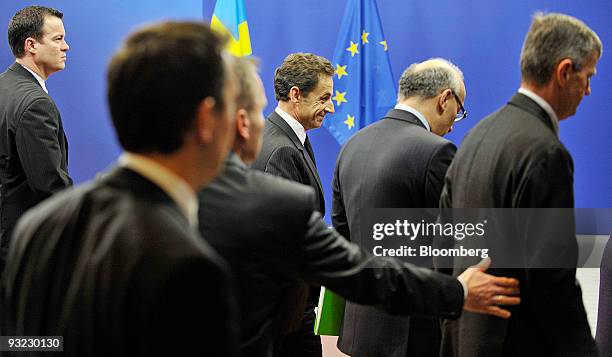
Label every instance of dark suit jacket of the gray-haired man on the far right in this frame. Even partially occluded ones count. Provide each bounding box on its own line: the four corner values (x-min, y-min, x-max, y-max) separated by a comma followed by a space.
440, 94, 597, 357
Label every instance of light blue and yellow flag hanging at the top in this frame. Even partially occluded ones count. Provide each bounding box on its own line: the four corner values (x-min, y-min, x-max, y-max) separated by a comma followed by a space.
210, 0, 252, 57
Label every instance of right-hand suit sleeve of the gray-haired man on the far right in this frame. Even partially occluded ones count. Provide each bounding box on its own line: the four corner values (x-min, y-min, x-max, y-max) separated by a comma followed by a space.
516, 147, 596, 356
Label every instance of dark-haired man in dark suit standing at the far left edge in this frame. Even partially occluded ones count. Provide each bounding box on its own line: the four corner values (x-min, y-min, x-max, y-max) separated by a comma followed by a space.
0, 6, 72, 276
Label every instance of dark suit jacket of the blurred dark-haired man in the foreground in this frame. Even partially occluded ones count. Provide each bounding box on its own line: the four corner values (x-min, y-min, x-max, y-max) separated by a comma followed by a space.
0, 168, 237, 356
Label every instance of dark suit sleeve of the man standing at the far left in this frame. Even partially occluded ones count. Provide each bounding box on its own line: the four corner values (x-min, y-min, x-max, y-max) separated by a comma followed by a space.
15, 99, 72, 197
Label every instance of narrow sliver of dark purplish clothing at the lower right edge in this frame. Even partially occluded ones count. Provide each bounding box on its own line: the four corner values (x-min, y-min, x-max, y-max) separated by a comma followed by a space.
597, 235, 612, 357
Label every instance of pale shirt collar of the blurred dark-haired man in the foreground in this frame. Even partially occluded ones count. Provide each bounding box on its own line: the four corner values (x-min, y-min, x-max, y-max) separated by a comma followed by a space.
118, 152, 198, 227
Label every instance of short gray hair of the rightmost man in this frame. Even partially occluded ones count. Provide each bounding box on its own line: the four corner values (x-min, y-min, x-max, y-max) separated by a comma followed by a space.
521, 12, 603, 85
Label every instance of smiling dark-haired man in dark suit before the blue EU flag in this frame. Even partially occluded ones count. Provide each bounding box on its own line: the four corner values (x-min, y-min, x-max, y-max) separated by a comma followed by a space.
253, 53, 334, 356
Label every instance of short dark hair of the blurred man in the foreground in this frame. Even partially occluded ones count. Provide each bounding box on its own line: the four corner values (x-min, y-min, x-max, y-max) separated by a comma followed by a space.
107, 22, 226, 154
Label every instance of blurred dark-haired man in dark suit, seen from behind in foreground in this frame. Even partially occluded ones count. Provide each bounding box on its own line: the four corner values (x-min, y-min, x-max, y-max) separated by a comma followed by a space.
0, 22, 237, 356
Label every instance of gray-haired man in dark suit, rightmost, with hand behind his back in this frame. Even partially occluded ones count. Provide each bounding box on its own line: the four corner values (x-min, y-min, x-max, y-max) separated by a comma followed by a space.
441, 14, 602, 357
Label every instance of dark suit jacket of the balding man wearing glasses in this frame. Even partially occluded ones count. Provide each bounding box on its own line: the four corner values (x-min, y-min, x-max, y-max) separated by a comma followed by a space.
332, 109, 456, 357
